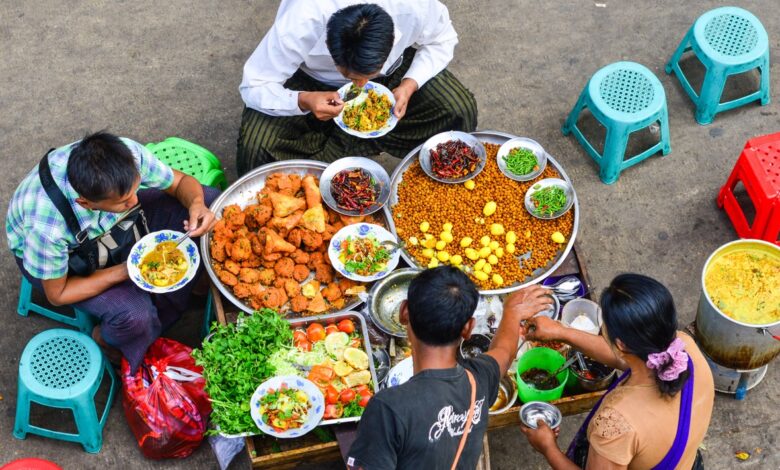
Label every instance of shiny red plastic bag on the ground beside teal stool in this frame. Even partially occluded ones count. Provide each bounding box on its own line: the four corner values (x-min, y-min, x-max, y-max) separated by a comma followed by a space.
122, 338, 211, 459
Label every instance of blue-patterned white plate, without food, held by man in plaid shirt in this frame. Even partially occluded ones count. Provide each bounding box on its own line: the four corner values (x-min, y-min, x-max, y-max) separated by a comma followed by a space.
127, 230, 200, 294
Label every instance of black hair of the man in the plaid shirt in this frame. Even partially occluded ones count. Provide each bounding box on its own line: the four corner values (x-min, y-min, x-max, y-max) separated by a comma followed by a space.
67, 131, 139, 201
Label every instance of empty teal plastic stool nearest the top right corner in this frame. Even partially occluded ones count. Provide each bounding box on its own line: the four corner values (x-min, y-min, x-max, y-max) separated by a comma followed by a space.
666, 7, 770, 125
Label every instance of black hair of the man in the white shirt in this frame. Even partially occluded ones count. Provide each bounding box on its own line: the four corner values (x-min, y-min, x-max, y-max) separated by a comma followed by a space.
325, 3, 395, 75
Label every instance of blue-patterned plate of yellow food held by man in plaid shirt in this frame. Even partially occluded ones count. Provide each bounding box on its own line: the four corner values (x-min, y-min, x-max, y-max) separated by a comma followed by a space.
127, 230, 200, 294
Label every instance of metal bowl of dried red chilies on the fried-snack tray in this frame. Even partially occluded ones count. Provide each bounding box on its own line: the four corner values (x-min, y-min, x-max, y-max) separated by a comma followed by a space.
320, 157, 390, 216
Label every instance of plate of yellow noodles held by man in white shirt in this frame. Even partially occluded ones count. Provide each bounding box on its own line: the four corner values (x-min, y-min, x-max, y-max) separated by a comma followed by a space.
334, 82, 398, 139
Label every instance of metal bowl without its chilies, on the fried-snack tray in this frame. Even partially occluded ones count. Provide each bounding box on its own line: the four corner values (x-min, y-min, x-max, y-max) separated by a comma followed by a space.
320, 157, 390, 217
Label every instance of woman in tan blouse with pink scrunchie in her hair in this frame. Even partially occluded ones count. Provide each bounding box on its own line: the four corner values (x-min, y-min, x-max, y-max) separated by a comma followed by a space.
522, 274, 715, 470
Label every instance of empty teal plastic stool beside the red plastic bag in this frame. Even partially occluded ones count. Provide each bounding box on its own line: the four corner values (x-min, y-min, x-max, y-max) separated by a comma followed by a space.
14, 328, 117, 453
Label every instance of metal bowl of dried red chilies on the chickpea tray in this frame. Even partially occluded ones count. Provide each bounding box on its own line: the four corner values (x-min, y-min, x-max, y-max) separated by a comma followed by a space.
419, 131, 487, 184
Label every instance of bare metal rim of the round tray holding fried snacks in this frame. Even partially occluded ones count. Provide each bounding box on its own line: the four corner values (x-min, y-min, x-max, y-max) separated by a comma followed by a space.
200, 160, 388, 313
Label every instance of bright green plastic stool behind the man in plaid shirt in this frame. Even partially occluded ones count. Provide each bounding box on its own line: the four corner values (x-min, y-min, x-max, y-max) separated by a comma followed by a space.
146, 137, 227, 190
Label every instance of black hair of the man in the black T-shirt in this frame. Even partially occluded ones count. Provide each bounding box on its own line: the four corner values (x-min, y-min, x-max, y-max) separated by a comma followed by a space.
407, 266, 479, 346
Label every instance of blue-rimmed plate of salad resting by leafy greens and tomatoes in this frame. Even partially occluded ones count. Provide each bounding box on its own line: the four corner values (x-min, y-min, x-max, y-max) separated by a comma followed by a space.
249, 376, 325, 438
